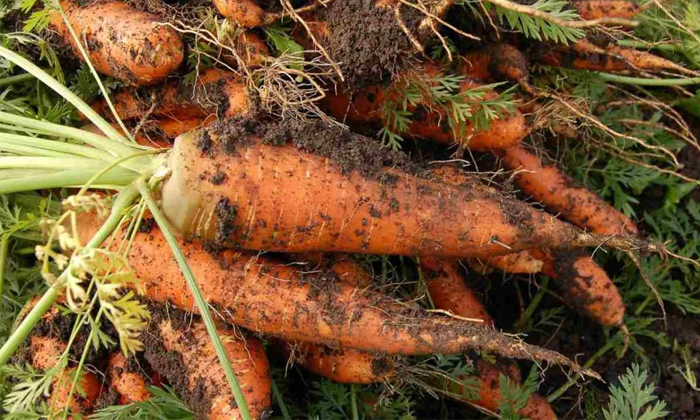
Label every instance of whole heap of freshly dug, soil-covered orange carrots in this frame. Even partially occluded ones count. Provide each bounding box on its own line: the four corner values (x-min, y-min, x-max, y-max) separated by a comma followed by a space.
0, 0, 693, 420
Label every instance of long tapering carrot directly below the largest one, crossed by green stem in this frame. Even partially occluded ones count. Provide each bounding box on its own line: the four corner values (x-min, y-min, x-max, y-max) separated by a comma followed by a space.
80, 214, 578, 370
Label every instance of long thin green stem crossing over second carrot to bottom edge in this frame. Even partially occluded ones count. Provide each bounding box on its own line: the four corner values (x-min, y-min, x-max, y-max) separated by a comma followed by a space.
136, 178, 251, 420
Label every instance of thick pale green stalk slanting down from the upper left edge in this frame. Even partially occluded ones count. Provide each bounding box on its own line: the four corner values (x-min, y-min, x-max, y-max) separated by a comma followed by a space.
0, 46, 125, 143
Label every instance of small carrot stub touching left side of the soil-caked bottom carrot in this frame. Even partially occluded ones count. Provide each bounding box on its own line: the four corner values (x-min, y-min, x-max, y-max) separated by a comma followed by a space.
107, 351, 151, 404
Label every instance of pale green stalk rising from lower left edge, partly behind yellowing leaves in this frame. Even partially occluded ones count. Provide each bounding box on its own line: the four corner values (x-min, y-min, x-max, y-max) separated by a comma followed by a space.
0, 186, 139, 366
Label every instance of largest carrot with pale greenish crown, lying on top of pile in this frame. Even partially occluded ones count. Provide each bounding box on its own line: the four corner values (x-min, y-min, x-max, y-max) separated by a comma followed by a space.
161, 130, 585, 257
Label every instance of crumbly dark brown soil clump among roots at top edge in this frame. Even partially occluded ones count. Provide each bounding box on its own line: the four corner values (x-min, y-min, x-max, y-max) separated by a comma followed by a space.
324, 0, 425, 90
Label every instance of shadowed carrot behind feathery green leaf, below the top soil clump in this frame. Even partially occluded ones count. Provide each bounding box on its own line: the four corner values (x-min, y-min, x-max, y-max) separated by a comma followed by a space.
324, 63, 528, 151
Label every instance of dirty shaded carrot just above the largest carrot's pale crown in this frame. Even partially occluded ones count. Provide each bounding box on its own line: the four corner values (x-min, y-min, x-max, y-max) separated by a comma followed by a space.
93, 69, 250, 120
